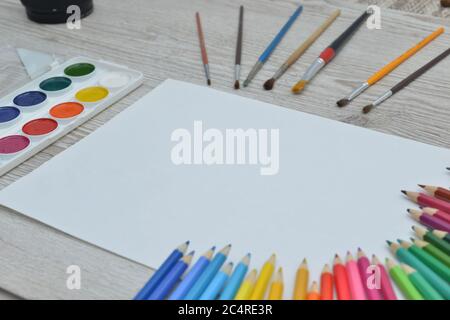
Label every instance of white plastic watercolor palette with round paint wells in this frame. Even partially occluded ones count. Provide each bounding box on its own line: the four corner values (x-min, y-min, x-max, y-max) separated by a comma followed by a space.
0, 57, 143, 175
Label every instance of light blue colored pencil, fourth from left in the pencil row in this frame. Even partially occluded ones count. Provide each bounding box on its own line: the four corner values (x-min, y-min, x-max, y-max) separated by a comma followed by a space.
184, 245, 231, 300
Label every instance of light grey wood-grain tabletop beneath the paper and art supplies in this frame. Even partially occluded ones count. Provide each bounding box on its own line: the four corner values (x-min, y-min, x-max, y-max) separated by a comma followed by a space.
0, 0, 450, 299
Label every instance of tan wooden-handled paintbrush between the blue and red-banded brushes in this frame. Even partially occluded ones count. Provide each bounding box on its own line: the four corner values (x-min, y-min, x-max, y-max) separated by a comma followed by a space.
264, 9, 341, 90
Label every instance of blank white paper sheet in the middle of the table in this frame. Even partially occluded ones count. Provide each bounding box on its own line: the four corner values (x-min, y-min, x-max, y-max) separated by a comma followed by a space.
0, 80, 450, 297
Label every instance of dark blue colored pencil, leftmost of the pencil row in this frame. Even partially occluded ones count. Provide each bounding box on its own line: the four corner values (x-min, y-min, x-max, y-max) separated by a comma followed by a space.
134, 241, 189, 300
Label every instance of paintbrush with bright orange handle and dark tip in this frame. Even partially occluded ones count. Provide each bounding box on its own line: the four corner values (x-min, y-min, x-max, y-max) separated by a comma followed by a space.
337, 28, 444, 108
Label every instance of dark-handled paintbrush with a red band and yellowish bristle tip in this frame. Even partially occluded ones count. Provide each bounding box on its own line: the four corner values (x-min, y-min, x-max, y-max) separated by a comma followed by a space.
292, 10, 372, 93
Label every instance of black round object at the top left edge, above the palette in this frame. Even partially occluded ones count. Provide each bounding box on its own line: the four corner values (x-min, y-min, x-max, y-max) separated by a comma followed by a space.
21, 0, 94, 24
